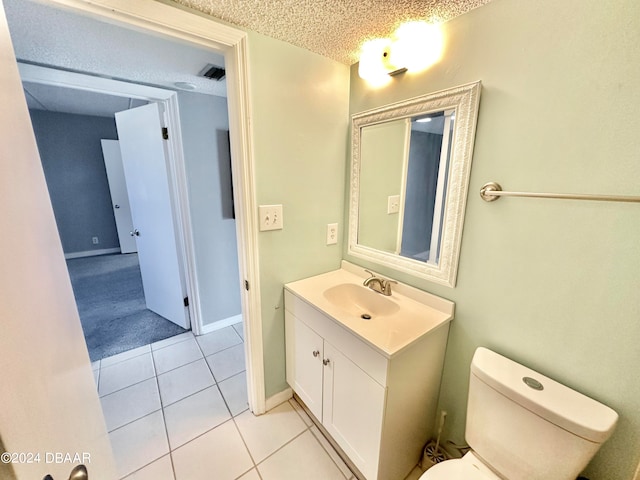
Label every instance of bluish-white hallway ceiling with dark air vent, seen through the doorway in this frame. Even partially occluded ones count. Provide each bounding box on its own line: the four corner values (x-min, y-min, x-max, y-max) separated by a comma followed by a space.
2, 0, 226, 96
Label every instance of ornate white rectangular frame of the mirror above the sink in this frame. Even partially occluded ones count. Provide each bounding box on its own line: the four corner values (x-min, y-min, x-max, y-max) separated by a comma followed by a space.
347, 81, 481, 287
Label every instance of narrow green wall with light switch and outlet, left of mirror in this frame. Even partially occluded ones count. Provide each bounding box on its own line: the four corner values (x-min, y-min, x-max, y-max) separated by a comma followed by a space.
248, 32, 349, 398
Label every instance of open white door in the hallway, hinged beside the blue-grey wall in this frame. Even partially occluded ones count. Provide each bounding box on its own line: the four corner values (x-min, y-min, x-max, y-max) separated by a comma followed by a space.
116, 103, 189, 328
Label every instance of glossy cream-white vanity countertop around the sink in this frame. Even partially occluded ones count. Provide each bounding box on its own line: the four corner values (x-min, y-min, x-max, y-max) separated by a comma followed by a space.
285, 261, 455, 358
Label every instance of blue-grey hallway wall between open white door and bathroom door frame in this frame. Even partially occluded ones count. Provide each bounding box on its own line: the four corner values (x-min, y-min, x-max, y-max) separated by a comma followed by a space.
178, 92, 242, 326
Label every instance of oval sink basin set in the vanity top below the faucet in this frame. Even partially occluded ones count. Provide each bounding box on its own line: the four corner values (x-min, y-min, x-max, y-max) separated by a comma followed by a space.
324, 283, 400, 319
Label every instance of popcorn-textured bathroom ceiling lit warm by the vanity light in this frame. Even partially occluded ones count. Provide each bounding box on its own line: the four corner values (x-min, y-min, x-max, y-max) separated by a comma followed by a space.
174, 0, 491, 65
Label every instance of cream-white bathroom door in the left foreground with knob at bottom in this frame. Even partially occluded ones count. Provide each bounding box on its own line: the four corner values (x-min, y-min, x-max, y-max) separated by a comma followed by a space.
0, 3, 117, 480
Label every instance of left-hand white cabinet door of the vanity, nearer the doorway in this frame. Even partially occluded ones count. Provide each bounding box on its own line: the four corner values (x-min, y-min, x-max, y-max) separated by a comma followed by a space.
285, 311, 323, 421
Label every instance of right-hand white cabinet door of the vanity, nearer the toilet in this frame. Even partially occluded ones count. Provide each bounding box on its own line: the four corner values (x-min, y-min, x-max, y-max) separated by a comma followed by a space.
322, 341, 386, 479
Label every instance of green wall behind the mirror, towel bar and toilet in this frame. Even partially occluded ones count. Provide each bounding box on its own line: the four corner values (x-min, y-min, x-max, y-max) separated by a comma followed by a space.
345, 0, 640, 480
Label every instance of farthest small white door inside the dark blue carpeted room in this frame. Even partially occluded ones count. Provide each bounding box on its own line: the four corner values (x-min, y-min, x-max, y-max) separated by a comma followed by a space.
100, 140, 138, 253
